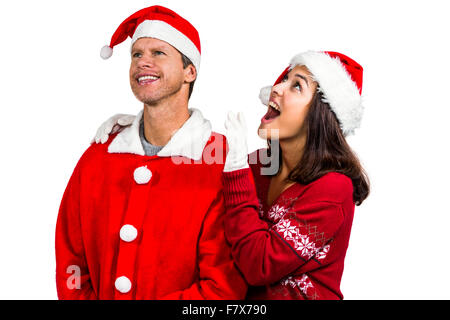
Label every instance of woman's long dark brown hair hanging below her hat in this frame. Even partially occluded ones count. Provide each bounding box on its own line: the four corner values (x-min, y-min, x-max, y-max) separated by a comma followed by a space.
269, 91, 370, 205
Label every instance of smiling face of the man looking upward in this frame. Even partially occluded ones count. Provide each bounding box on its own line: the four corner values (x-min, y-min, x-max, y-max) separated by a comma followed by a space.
130, 38, 195, 105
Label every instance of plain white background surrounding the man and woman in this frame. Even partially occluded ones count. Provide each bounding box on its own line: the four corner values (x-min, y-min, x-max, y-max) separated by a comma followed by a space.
0, 0, 450, 299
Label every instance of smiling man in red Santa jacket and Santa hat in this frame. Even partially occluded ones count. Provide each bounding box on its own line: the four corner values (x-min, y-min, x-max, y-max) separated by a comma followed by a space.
56, 6, 247, 299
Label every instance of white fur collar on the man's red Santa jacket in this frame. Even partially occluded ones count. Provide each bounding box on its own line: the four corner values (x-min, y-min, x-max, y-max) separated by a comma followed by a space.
108, 108, 212, 160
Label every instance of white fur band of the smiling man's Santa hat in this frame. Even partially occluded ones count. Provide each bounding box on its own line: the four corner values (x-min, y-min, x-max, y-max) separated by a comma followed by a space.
131, 20, 201, 73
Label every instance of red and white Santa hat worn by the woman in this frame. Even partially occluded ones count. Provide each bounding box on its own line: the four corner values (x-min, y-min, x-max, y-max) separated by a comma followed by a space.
259, 51, 363, 135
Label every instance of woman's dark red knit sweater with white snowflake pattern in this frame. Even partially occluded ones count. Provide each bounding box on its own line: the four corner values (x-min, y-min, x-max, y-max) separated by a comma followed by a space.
223, 150, 355, 300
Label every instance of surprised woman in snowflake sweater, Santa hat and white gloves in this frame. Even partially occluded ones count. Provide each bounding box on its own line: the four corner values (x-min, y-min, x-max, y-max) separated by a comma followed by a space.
97, 52, 369, 299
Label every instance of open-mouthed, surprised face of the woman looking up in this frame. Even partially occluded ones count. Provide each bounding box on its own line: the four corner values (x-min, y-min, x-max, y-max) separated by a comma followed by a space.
258, 66, 317, 140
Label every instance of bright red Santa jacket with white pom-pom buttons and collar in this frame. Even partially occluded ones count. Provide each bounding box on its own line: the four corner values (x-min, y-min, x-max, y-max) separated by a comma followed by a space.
56, 109, 247, 299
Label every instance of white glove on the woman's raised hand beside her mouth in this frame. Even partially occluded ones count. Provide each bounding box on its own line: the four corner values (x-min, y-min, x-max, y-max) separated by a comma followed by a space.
223, 111, 248, 172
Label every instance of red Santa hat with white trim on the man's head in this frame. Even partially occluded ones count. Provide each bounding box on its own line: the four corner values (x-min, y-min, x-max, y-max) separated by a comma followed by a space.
100, 6, 201, 72
